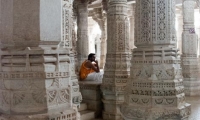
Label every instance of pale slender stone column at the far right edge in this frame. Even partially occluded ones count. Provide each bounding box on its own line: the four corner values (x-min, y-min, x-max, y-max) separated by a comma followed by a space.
182, 0, 200, 96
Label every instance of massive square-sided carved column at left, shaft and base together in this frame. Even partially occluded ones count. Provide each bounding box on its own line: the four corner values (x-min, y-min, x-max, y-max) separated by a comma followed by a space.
0, 0, 81, 120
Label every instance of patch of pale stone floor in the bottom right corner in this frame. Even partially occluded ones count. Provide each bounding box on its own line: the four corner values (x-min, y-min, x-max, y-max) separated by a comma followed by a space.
186, 97, 200, 120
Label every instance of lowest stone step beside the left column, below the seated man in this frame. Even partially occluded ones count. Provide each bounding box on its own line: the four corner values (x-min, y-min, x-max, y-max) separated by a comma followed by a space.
80, 110, 95, 120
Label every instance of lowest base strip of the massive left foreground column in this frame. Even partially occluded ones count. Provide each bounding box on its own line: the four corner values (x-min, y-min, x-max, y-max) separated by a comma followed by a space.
0, 110, 80, 120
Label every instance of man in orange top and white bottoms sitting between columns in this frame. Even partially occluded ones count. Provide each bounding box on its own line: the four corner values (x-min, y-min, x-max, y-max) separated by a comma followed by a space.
79, 53, 103, 81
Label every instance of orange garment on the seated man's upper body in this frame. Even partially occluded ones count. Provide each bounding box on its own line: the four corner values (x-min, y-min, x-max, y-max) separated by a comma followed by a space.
79, 60, 95, 80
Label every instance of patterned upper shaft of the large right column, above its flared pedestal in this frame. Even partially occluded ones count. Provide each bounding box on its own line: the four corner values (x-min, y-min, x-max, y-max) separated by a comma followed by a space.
135, 0, 176, 46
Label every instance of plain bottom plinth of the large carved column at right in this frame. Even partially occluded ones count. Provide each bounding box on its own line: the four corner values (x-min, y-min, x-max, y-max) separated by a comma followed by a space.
121, 103, 191, 120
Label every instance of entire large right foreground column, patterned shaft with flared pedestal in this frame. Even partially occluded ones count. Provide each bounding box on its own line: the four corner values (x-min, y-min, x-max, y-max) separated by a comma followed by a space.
121, 0, 190, 120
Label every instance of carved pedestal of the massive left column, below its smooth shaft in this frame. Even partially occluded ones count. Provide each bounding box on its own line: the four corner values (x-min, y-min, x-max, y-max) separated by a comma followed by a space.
0, 47, 81, 120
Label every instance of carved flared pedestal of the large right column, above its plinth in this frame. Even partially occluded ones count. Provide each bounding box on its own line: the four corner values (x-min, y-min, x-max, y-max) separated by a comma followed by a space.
121, 47, 189, 120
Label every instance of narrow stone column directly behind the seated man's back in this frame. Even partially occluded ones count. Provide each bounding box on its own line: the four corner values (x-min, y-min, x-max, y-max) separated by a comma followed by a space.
77, 0, 89, 66
